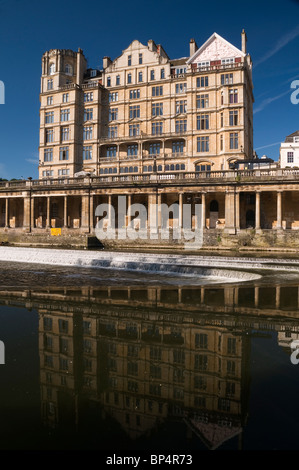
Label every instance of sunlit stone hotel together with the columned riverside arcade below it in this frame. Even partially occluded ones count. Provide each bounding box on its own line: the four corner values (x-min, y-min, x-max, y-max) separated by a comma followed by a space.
0, 31, 299, 246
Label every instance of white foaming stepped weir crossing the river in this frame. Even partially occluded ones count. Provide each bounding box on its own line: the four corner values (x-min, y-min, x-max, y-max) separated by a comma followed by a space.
0, 247, 299, 282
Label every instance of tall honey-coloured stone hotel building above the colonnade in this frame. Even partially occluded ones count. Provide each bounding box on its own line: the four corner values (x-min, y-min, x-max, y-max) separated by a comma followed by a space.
39, 31, 253, 178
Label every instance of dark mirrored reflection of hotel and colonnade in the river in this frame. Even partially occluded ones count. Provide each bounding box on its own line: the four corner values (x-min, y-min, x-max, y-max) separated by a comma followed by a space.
1, 280, 299, 449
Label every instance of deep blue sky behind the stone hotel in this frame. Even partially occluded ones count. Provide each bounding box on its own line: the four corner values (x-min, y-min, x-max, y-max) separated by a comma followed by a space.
0, 0, 299, 179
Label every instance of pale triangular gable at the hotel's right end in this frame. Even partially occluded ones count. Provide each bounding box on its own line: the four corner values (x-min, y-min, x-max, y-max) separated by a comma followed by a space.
187, 33, 246, 64
